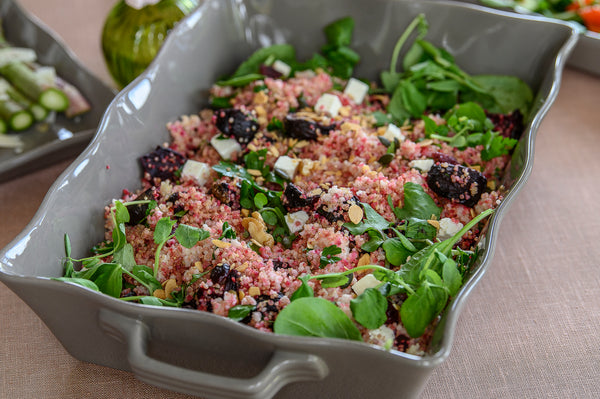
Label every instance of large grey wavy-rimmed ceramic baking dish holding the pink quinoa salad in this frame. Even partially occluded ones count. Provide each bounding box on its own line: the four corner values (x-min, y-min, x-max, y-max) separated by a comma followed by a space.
0, 0, 577, 398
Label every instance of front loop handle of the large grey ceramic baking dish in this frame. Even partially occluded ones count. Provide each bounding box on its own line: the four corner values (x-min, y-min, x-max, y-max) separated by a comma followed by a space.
99, 309, 329, 399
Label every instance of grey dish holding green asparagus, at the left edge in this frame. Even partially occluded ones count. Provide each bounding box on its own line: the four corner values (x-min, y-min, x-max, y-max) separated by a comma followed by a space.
0, 0, 116, 181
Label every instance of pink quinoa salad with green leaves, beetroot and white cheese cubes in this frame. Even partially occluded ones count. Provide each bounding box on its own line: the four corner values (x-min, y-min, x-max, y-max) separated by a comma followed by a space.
61, 16, 527, 355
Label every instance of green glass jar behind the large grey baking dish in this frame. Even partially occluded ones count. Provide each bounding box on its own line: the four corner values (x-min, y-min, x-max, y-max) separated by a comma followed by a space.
102, 0, 198, 87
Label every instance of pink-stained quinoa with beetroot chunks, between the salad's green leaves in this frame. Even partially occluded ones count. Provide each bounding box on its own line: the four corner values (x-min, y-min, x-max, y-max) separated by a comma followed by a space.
96, 67, 509, 354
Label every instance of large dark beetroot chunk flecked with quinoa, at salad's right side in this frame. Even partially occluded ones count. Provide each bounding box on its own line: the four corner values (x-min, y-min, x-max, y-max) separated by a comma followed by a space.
427, 162, 487, 207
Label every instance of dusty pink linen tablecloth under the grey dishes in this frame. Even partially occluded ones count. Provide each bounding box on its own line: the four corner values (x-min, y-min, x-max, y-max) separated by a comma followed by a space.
0, 0, 600, 399
